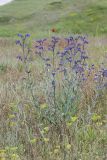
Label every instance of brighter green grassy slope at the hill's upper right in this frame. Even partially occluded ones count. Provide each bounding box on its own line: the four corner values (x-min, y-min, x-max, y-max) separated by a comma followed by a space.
56, 3, 107, 35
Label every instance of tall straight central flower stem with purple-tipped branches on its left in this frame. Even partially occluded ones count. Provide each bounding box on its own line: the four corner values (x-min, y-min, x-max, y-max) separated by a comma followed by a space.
36, 37, 59, 120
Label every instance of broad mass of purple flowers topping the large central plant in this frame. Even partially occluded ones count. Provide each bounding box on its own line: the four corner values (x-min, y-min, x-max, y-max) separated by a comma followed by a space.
35, 36, 88, 83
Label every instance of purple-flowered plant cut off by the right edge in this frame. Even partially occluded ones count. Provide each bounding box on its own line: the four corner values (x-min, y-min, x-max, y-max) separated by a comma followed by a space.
88, 59, 107, 110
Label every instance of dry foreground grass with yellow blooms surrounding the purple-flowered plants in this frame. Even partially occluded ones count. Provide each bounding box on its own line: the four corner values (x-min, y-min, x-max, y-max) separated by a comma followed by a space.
0, 38, 107, 160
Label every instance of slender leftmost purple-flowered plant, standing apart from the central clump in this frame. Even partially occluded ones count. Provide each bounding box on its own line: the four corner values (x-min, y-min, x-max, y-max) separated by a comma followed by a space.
16, 33, 38, 107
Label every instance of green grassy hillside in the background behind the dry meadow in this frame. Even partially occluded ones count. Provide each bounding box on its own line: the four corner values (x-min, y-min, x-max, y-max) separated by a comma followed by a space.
0, 0, 107, 37
